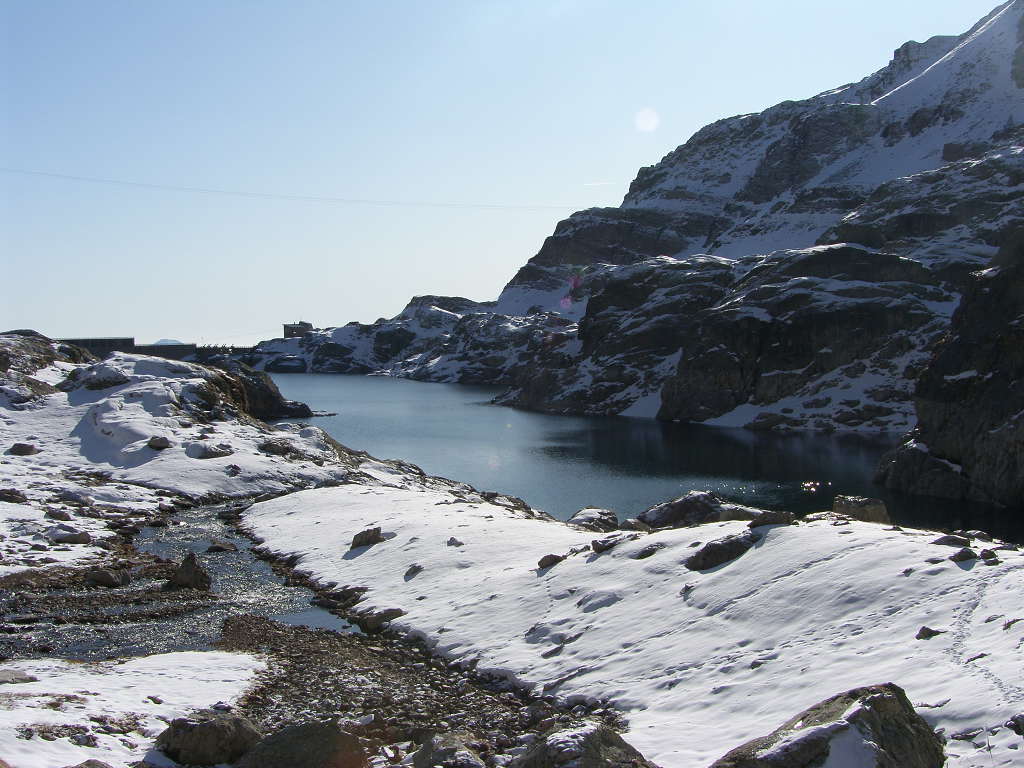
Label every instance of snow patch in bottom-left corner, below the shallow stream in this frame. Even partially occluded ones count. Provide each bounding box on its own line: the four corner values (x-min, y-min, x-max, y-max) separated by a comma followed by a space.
0, 651, 265, 768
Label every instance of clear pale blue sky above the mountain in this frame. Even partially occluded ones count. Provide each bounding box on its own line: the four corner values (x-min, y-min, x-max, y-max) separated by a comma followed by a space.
0, 0, 996, 344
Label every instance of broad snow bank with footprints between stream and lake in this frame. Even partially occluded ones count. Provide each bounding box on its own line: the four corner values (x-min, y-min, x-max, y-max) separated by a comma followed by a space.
244, 484, 1024, 768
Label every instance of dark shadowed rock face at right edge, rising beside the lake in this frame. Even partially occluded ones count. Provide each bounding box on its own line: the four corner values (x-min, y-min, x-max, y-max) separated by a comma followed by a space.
879, 239, 1024, 507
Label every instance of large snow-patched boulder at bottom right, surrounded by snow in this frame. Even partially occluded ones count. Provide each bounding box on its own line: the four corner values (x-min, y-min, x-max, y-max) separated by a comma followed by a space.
711, 683, 946, 768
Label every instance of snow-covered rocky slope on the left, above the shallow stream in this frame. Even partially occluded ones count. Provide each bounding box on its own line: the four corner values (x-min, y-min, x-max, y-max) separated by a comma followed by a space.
0, 354, 347, 510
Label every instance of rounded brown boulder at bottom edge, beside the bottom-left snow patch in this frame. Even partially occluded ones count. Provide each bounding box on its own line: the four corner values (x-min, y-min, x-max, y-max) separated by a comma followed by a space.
157, 712, 260, 766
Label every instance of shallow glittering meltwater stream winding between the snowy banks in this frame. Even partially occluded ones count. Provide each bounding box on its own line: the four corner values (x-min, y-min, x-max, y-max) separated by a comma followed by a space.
4, 505, 359, 659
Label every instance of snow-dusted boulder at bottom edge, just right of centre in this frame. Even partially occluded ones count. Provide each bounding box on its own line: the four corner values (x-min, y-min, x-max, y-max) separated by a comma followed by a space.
510, 723, 655, 768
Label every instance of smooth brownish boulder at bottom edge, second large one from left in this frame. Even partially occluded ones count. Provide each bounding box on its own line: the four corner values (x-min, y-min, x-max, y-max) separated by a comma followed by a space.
236, 720, 369, 768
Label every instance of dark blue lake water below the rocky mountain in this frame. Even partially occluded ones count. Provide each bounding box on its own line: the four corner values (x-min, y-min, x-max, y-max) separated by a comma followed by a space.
273, 374, 1013, 536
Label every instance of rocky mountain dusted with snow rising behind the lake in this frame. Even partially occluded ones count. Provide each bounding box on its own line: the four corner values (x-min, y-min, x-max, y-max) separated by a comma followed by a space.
241, 0, 1024, 431
